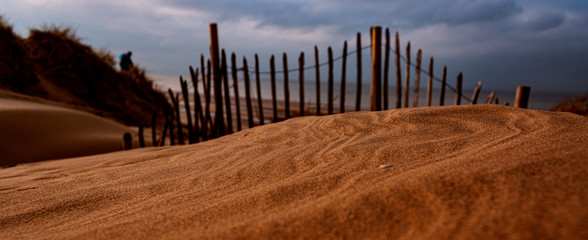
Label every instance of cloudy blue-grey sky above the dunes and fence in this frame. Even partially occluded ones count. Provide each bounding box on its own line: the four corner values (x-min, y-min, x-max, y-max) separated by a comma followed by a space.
0, 0, 588, 93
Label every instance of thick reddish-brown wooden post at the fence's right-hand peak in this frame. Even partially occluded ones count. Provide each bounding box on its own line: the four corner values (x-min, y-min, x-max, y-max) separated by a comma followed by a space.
370, 26, 382, 111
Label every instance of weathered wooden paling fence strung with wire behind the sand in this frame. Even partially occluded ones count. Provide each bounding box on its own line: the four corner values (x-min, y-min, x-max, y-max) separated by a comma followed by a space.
125, 23, 530, 147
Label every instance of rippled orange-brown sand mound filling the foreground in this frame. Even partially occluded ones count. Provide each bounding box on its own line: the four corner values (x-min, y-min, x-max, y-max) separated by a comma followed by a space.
0, 105, 588, 239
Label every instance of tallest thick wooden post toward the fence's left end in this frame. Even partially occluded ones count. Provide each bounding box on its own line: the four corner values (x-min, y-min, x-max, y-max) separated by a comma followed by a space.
209, 23, 225, 137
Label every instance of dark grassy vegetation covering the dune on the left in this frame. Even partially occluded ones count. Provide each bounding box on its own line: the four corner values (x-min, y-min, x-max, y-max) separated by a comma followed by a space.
0, 16, 169, 125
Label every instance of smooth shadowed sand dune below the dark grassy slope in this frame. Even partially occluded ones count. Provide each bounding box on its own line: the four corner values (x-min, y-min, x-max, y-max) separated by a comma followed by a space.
0, 99, 132, 166
